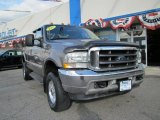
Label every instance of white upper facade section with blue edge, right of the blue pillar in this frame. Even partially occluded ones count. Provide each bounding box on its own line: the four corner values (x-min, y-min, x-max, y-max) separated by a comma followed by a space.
81, 0, 160, 23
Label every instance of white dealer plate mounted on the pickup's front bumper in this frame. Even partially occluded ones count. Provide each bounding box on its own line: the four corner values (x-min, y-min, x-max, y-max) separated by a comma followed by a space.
119, 80, 132, 91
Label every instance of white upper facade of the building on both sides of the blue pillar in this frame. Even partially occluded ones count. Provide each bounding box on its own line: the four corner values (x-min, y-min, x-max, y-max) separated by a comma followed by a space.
0, 0, 160, 39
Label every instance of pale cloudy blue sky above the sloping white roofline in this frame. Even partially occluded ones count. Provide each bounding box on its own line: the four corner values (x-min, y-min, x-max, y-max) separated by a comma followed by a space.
0, 0, 68, 24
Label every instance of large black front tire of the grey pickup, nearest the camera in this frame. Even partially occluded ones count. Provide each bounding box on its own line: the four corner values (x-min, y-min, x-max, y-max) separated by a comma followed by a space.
46, 72, 71, 112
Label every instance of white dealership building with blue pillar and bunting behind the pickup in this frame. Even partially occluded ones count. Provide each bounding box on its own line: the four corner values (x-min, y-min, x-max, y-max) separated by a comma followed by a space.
0, 0, 160, 66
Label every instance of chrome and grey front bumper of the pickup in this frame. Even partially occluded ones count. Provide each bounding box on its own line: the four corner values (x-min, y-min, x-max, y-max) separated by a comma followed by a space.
59, 64, 144, 100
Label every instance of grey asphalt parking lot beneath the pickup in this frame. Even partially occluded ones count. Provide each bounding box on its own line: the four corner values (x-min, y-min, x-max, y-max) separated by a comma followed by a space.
0, 67, 160, 120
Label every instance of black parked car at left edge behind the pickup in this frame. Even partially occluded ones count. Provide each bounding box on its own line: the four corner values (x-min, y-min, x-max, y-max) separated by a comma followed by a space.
0, 49, 22, 69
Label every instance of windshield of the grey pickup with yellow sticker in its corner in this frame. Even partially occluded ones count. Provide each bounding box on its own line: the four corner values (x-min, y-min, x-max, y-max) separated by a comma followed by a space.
46, 25, 99, 40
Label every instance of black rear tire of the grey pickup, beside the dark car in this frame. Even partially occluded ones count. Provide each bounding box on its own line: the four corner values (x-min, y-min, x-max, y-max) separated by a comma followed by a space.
22, 62, 32, 81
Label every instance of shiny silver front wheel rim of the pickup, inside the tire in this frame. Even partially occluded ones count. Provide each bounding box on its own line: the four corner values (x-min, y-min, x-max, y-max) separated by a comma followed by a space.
48, 80, 56, 105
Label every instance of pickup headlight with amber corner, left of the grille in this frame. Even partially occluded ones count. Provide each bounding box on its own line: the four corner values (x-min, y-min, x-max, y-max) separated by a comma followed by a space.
63, 52, 89, 68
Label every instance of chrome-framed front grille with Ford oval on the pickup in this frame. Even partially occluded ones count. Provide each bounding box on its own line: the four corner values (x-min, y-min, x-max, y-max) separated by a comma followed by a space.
89, 46, 137, 71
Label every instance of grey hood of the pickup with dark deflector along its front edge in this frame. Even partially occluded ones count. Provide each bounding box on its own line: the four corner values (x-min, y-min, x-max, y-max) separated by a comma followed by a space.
55, 39, 139, 53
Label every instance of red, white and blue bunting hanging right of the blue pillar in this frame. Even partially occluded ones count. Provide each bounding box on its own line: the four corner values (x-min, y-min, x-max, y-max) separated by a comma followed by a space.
84, 11, 160, 30
